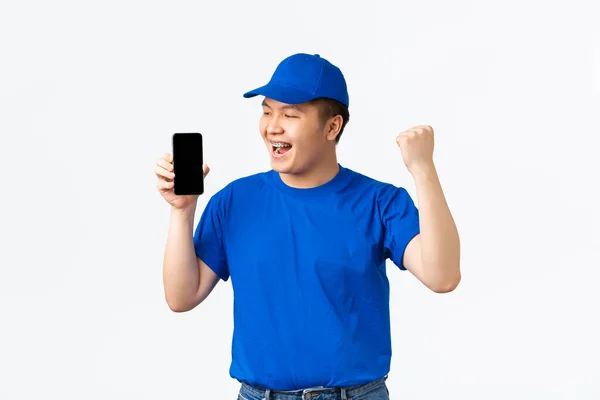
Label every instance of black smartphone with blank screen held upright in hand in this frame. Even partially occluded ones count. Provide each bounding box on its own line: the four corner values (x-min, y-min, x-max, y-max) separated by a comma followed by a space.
173, 132, 204, 195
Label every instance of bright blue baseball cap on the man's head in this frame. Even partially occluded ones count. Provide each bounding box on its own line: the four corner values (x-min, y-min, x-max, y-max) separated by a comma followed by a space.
244, 53, 349, 107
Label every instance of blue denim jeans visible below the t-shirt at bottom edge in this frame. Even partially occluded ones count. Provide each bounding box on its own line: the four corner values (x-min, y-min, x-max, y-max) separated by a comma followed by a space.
237, 376, 390, 400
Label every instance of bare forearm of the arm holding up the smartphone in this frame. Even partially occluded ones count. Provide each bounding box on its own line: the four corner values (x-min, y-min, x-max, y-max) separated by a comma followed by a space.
163, 205, 200, 309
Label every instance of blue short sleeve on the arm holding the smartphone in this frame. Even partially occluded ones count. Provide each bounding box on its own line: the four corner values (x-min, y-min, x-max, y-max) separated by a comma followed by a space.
194, 193, 229, 281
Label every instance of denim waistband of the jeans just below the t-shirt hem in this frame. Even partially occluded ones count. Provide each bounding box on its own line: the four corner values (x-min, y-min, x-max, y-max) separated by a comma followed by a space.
242, 375, 388, 400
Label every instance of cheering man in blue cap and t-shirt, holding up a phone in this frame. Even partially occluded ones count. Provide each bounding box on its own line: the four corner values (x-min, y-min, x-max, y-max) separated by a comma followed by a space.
156, 54, 460, 400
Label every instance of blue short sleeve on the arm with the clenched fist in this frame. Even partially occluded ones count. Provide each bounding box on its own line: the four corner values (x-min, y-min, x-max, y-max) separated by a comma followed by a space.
378, 185, 420, 270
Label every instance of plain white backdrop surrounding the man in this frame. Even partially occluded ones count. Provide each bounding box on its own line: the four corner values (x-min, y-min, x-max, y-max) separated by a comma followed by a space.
0, 0, 600, 400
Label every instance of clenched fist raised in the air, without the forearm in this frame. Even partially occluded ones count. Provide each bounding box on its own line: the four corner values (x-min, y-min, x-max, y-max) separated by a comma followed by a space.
396, 125, 433, 174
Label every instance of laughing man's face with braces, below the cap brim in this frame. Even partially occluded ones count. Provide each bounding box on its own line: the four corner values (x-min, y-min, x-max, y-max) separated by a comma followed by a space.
259, 98, 335, 174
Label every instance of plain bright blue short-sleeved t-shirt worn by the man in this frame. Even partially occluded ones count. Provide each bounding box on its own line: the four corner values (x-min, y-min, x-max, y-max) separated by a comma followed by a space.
194, 165, 419, 390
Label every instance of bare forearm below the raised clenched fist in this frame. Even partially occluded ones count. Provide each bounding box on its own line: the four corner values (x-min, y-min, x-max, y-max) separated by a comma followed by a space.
413, 166, 460, 288
